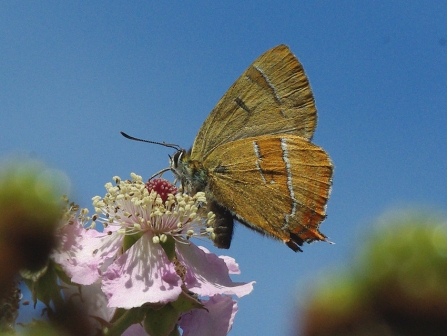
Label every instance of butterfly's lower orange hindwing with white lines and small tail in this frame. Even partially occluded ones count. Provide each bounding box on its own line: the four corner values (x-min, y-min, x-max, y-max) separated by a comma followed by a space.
203, 135, 333, 247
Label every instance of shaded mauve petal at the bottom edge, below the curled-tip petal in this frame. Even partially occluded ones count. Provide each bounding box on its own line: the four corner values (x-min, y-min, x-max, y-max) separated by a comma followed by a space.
179, 295, 237, 336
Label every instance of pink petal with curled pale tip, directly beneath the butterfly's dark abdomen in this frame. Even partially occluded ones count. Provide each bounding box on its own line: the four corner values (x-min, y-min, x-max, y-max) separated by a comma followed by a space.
175, 243, 255, 297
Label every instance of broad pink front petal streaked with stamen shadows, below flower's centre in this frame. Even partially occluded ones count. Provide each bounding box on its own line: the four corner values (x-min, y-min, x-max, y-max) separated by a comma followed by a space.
102, 234, 182, 308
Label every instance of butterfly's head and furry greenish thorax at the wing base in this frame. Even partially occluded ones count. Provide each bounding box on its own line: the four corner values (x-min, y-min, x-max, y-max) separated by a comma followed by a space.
170, 149, 208, 195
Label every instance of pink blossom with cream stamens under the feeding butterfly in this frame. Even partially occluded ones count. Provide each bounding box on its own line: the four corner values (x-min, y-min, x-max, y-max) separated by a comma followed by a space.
54, 174, 254, 309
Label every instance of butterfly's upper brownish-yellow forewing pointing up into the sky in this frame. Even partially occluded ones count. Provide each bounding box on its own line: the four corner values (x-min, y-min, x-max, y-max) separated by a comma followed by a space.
191, 45, 316, 160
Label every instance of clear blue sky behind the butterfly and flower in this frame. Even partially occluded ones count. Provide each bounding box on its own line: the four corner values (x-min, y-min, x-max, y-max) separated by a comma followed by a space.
0, 1, 447, 335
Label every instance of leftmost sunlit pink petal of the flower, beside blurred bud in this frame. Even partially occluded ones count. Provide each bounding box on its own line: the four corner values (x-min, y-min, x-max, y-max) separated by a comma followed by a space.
53, 222, 124, 285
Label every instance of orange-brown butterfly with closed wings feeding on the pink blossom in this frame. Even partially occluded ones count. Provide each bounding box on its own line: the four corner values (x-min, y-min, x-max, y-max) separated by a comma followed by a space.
122, 45, 333, 251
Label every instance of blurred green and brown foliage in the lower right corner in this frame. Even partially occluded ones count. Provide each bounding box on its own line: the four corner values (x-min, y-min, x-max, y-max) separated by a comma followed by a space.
303, 213, 447, 335
